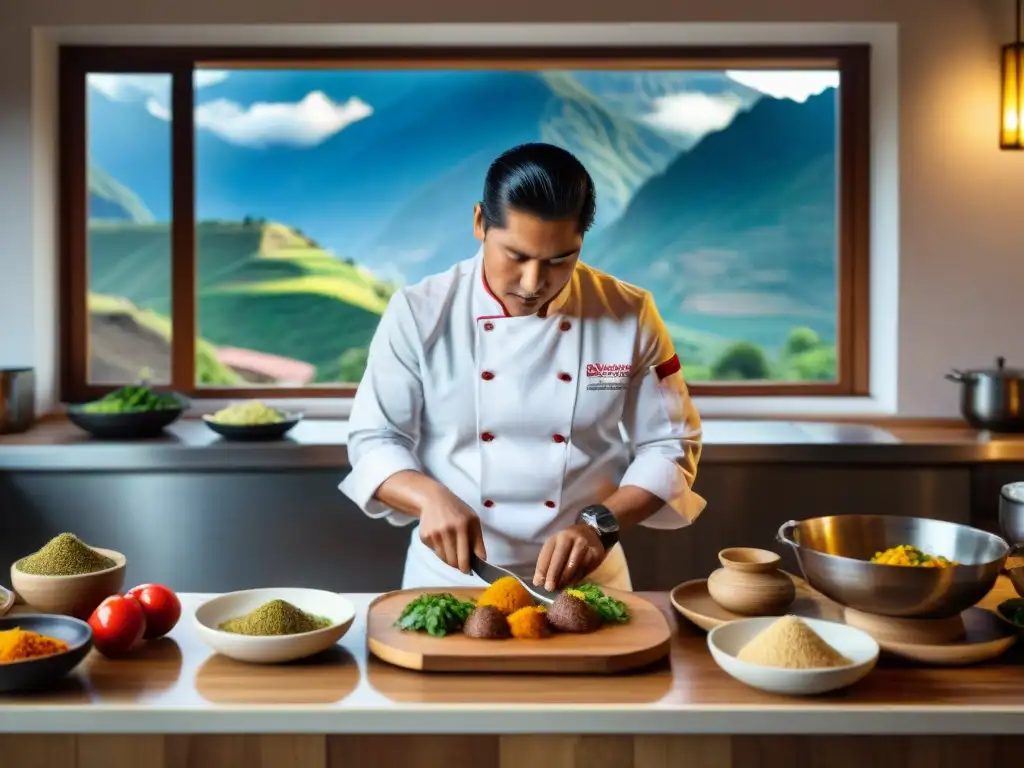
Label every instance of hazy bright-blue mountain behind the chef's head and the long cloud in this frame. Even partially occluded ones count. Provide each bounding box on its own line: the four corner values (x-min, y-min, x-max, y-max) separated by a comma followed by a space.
88, 71, 679, 281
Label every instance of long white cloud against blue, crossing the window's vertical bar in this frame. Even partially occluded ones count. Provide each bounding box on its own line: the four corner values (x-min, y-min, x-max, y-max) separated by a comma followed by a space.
145, 91, 374, 147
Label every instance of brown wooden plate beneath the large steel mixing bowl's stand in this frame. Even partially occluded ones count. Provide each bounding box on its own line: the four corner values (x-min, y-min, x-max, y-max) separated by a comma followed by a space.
845, 607, 1017, 667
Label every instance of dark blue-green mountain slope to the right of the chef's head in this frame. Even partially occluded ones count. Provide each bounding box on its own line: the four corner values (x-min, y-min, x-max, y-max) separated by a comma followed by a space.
584, 89, 838, 348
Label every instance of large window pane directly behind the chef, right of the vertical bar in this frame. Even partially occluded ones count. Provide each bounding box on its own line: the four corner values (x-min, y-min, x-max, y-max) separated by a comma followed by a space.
195, 70, 839, 387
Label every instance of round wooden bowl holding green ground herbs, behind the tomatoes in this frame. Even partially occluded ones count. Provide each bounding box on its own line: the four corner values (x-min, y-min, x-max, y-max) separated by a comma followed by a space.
10, 547, 128, 620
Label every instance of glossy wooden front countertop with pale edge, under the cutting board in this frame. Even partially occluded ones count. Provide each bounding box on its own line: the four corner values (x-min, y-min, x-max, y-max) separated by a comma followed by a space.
0, 578, 1024, 734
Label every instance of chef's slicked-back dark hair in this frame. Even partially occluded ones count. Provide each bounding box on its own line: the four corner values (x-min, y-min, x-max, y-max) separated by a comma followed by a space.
480, 142, 597, 232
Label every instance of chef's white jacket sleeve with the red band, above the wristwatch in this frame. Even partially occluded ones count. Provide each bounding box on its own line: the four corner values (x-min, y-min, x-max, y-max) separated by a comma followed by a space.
620, 295, 707, 528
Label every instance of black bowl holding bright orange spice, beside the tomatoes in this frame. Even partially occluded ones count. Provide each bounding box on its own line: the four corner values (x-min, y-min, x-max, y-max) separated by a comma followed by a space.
0, 613, 92, 693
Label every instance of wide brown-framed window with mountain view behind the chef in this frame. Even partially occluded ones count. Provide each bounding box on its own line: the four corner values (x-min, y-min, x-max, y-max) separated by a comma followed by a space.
60, 46, 869, 400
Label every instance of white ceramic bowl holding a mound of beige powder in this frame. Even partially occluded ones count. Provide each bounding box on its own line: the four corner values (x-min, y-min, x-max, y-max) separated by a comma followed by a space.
708, 616, 879, 696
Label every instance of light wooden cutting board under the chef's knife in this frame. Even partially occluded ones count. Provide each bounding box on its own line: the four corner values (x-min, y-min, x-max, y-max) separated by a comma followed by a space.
367, 589, 672, 675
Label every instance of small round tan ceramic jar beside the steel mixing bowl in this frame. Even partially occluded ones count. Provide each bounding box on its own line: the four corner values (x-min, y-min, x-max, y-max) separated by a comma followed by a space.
708, 547, 797, 616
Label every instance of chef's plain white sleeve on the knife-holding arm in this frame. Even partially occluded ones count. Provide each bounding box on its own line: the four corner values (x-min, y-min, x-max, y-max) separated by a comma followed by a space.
339, 291, 423, 525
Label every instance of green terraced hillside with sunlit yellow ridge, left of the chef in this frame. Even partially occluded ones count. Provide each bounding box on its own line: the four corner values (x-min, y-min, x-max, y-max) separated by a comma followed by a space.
89, 219, 394, 383
